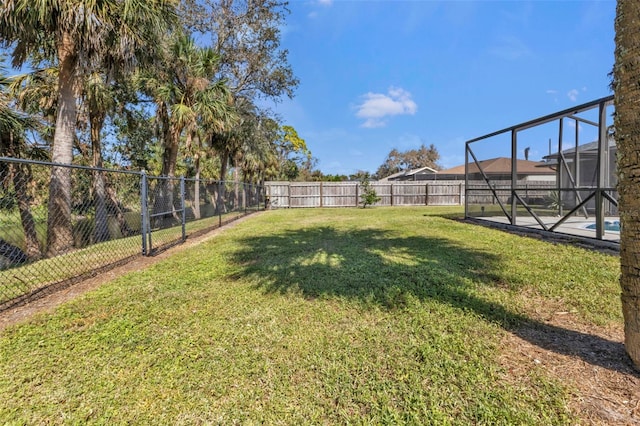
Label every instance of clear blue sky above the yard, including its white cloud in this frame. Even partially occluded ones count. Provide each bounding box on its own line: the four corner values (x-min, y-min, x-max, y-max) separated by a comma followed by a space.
272, 0, 616, 175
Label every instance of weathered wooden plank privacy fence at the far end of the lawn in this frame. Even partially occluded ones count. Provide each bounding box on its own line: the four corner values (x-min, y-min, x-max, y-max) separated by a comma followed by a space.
265, 181, 464, 208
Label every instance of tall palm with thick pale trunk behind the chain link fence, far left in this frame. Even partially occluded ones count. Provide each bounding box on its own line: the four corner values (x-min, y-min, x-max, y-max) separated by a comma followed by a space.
0, 0, 176, 255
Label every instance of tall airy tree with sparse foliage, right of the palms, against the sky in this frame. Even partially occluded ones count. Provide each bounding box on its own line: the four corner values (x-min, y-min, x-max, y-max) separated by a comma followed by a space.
181, 0, 302, 188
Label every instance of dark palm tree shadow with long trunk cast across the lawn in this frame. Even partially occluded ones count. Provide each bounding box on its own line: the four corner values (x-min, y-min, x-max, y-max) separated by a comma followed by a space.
236, 227, 637, 376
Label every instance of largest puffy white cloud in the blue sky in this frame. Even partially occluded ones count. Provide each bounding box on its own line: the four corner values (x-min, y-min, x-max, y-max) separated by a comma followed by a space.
356, 87, 418, 128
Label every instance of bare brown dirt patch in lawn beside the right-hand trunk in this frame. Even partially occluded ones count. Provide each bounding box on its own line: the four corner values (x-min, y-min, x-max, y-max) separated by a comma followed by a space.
500, 311, 640, 425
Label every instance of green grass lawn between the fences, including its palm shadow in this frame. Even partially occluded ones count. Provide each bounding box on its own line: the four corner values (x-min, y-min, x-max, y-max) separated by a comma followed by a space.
0, 207, 621, 425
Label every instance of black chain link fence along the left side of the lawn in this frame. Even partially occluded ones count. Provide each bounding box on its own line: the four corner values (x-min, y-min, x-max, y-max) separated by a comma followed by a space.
0, 157, 264, 310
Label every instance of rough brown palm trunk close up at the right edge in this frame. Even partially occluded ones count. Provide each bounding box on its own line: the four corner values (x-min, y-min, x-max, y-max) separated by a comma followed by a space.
613, 0, 640, 369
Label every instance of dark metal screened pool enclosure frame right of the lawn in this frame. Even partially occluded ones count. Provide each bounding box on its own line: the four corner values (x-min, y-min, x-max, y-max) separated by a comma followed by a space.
465, 96, 619, 243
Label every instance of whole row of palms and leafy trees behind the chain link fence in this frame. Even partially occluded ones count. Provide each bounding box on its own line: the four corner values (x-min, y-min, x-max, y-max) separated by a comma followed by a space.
0, 0, 314, 255
